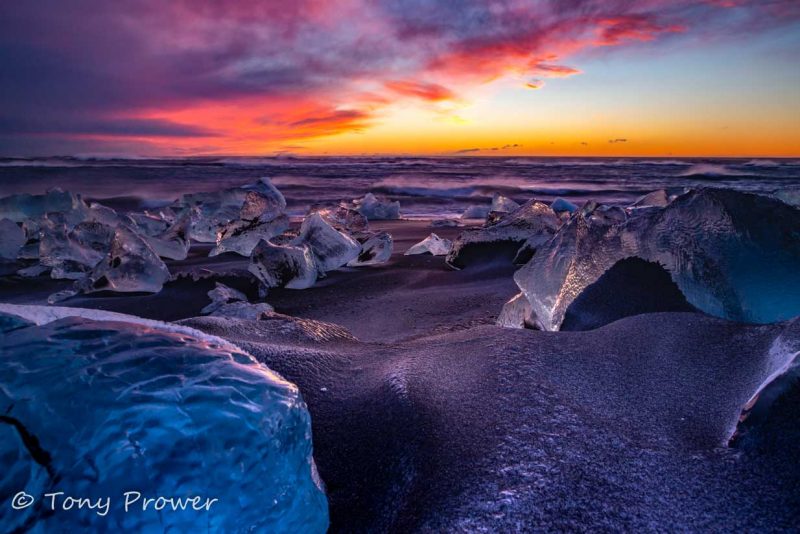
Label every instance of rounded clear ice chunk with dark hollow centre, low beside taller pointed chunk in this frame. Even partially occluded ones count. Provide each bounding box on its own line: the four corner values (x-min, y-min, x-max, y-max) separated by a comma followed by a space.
248, 241, 318, 289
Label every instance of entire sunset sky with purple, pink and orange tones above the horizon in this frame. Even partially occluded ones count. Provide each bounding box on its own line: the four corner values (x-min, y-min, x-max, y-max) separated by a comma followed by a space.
0, 0, 800, 157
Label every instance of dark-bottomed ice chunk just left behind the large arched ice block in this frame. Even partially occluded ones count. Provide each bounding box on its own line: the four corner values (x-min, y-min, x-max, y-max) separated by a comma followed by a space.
447, 200, 561, 269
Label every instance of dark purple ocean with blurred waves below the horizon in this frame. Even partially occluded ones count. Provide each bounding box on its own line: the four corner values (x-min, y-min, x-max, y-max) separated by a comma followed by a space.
0, 157, 800, 218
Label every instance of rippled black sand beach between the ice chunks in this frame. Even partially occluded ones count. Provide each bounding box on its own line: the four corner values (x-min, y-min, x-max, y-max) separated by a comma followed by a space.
0, 221, 800, 532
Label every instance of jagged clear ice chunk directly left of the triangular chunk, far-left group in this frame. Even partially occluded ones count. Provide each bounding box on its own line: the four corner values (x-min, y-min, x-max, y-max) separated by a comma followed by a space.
39, 221, 114, 280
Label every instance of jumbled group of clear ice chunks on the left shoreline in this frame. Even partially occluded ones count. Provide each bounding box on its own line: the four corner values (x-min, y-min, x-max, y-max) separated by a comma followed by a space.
0, 178, 400, 300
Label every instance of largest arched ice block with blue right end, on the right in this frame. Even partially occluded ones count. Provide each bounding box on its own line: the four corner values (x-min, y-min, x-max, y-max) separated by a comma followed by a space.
514, 189, 800, 330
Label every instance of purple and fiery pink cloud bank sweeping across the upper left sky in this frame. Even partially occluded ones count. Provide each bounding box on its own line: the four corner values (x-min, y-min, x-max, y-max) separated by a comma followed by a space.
0, 0, 800, 153
